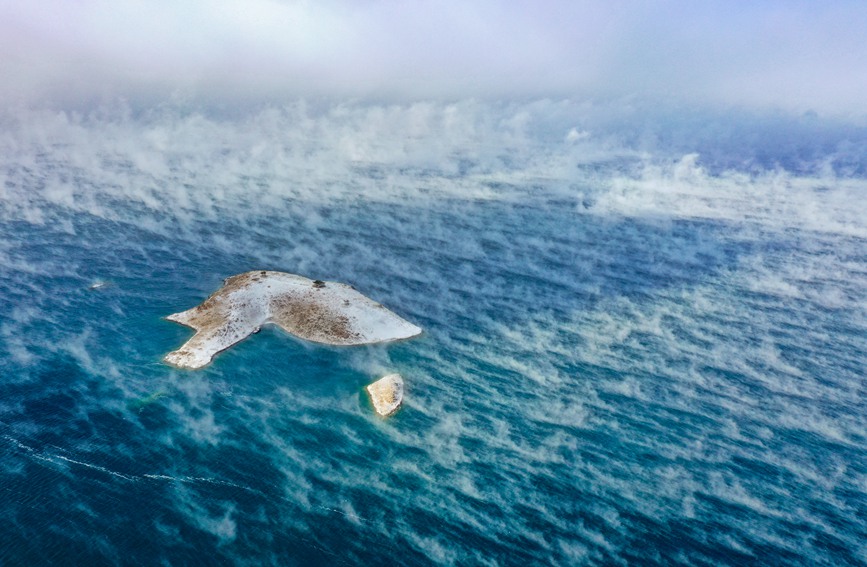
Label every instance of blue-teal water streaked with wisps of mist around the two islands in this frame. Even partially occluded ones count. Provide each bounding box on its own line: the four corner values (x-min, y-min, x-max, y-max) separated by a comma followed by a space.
0, 104, 867, 565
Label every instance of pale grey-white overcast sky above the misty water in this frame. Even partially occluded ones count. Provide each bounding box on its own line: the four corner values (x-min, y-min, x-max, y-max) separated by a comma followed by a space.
0, 0, 867, 116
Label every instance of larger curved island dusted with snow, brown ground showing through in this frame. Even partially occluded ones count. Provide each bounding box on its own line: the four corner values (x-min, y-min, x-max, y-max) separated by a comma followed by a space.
164, 271, 421, 368
